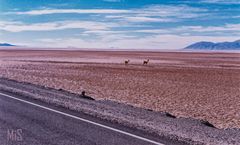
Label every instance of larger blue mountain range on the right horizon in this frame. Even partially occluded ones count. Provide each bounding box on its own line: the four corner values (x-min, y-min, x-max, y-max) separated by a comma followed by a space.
184, 40, 240, 50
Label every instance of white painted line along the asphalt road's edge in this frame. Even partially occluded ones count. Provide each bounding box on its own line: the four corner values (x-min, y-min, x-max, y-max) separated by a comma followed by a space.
0, 93, 164, 145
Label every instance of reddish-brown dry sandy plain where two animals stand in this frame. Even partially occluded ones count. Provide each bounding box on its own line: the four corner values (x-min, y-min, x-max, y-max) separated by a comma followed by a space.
0, 50, 240, 128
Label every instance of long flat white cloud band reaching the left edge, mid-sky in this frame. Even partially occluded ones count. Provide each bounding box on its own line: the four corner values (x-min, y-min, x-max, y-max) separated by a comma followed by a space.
0, 21, 114, 32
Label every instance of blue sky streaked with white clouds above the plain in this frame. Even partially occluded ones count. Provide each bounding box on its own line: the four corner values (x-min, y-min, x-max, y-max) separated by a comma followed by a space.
0, 0, 240, 49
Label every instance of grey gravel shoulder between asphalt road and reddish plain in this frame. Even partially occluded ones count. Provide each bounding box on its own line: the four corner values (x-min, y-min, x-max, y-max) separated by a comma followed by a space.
0, 78, 240, 145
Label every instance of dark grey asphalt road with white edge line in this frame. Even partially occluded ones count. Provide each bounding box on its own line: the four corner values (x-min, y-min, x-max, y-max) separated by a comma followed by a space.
0, 92, 182, 145
